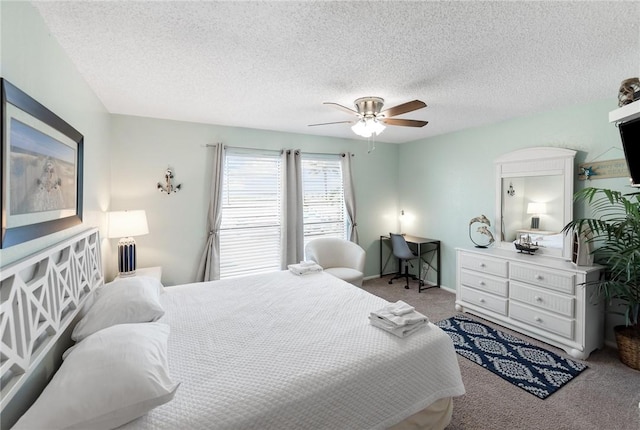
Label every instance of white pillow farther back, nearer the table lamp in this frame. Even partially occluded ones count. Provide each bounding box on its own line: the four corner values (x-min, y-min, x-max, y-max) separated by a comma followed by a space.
71, 276, 164, 342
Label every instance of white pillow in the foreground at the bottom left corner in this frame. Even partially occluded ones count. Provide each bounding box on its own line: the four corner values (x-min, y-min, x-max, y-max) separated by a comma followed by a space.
14, 323, 179, 429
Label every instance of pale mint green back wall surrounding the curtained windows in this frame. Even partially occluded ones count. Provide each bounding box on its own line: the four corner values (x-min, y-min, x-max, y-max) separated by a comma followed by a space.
108, 115, 398, 285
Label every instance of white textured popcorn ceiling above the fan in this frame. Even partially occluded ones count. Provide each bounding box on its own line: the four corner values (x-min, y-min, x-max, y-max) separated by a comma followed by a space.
34, 1, 640, 143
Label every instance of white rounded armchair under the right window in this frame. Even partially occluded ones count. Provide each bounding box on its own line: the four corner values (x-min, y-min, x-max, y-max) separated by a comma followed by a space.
304, 237, 366, 287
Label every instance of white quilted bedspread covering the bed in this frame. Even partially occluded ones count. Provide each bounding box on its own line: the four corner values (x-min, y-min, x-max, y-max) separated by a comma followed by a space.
124, 271, 464, 430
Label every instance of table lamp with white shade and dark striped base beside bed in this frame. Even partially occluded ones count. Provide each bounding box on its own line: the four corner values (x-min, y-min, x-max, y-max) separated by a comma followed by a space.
107, 210, 149, 276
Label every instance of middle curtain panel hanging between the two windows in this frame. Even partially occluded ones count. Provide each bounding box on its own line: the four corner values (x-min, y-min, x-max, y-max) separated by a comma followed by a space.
280, 149, 304, 270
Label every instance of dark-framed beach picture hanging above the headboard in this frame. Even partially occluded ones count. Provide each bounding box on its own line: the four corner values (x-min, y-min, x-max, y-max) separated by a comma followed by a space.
0, 78, 84, 249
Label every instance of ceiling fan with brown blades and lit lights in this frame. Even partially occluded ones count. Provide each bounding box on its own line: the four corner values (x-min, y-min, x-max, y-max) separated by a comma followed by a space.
309, 97, 428, 137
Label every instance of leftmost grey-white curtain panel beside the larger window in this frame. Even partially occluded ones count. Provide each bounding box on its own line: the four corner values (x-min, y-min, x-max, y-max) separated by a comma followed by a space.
196, 143, 224, 282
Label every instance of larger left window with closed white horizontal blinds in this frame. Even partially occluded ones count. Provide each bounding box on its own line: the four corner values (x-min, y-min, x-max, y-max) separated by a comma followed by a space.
220, 149, 282, 279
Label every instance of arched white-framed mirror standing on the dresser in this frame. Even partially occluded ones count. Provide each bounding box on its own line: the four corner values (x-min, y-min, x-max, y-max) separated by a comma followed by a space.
495, 147, 576, 260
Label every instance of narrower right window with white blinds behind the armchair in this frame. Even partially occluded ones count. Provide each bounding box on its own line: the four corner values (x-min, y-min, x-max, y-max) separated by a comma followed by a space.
302, 154, 347, 250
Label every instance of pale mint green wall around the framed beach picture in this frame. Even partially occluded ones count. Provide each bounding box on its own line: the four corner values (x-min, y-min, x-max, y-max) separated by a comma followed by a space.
0, 1, 110, 266
